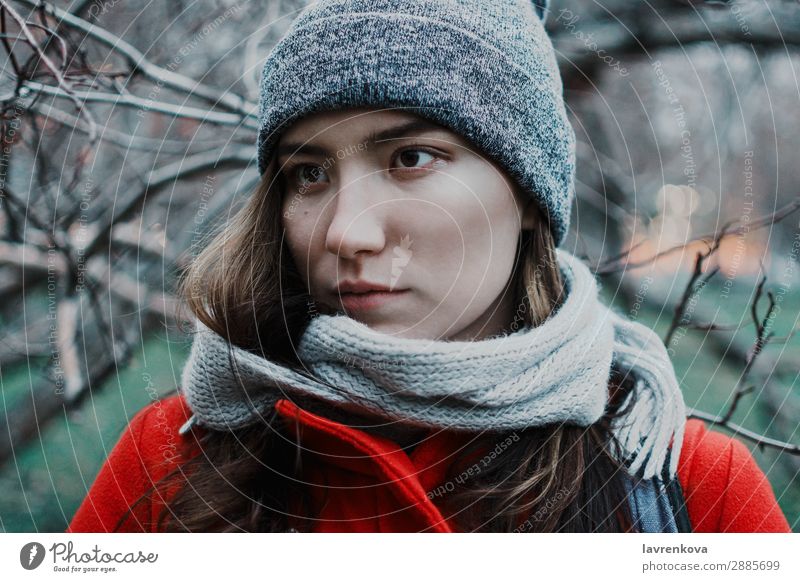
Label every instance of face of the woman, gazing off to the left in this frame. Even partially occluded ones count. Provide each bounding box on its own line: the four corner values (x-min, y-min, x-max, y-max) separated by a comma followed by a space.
277, 109, 534, 341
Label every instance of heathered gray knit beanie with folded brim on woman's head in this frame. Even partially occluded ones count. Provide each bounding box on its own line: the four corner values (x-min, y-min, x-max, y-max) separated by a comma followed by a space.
258, 0, 575, 244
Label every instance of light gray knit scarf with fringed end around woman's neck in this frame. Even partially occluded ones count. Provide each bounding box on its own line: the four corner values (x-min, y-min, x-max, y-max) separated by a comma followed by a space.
181, 249, 686, 479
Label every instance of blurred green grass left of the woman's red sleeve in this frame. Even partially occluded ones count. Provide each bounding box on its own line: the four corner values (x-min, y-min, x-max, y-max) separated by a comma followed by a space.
0, 333, 188, 532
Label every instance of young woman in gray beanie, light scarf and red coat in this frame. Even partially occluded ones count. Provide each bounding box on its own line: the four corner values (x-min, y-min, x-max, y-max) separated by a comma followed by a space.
68, 0, 789, 532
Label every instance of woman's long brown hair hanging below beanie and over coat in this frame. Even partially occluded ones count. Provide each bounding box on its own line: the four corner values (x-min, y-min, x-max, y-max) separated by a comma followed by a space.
118, 160, 633, 532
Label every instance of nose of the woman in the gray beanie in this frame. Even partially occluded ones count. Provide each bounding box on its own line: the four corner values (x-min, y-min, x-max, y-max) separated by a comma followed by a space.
325, 176, 386, 259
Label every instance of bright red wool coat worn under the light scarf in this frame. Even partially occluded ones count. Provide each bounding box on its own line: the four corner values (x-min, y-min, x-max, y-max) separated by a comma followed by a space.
66, 394, 791, 533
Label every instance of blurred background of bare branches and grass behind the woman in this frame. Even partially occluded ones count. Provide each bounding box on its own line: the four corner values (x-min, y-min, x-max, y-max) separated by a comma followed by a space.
0, 0, 800, 532
